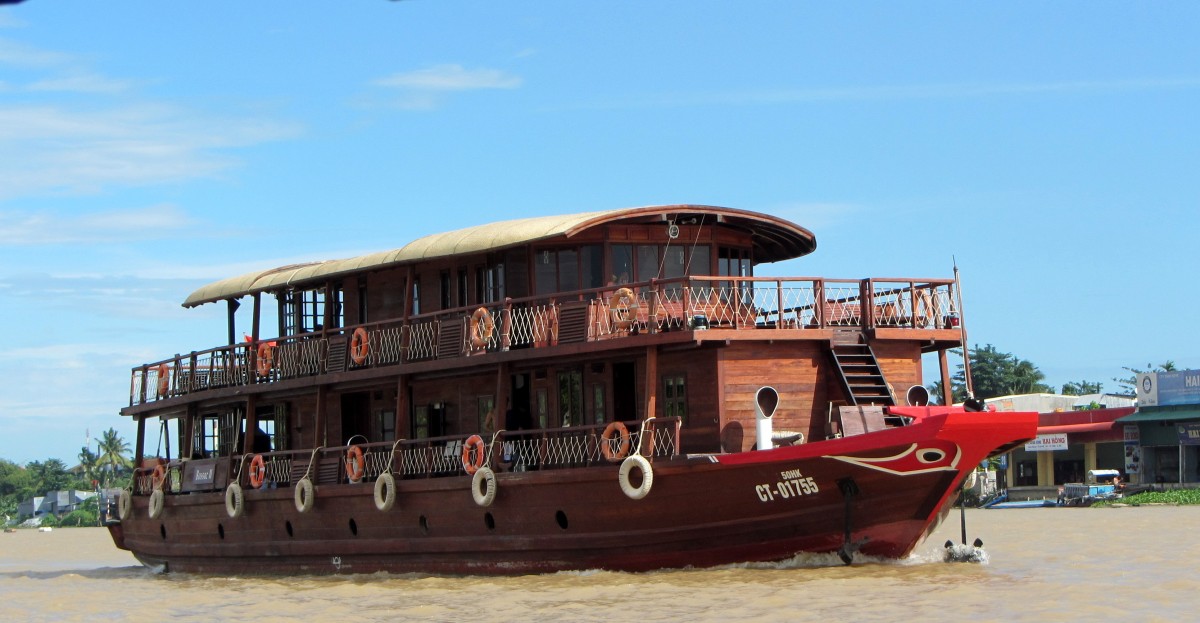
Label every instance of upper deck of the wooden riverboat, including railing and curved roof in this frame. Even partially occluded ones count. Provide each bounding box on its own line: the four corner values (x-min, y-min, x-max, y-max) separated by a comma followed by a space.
126, 205, 961, 413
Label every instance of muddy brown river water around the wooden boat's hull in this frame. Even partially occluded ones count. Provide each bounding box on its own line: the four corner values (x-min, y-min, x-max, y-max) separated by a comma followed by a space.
0, 507, 1200, 623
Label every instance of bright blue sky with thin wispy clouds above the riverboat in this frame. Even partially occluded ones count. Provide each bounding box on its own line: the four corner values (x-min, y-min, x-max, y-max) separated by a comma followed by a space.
0, 0, 1200, 465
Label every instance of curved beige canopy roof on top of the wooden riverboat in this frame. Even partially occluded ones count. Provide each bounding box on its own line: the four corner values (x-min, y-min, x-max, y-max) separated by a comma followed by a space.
184, 205, 817, 307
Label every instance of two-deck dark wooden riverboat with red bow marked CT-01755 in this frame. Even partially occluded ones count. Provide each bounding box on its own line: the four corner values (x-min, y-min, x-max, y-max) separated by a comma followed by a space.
109, 205, 1037, 574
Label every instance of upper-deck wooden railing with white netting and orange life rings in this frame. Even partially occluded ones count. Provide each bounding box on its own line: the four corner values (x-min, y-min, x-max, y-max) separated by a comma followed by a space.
130, 276, 960, 406
